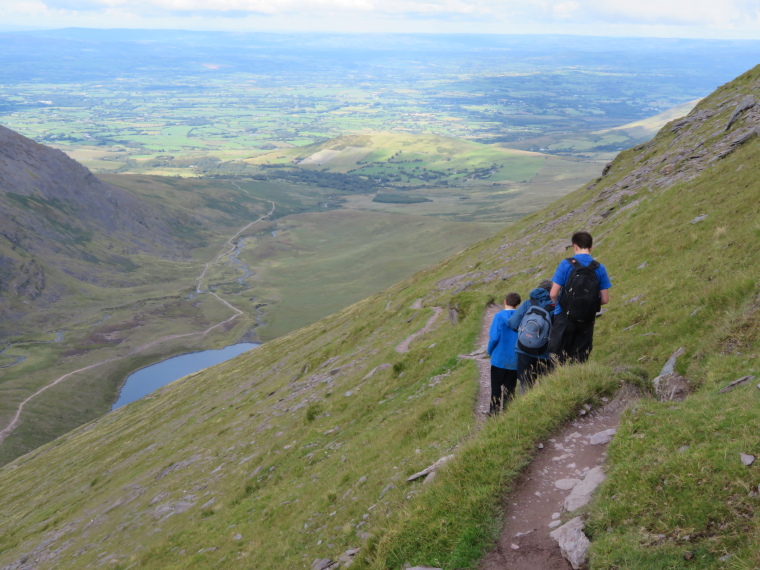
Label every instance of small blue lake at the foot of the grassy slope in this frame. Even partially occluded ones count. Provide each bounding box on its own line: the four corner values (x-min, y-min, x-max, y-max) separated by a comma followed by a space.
111, 342, 259, 411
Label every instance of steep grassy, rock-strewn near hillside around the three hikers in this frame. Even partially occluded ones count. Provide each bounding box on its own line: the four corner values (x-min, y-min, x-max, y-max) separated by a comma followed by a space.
0, 68, 760, 568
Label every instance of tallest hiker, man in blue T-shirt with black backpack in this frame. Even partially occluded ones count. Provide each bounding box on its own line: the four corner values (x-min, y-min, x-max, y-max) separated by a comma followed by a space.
549, 231, 612, 363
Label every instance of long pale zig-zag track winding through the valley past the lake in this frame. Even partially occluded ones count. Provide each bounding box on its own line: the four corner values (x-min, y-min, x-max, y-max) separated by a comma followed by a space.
0, 181, 276, 444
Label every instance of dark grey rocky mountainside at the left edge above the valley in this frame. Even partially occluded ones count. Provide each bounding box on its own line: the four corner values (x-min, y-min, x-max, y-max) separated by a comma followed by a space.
0, 126, 190, 336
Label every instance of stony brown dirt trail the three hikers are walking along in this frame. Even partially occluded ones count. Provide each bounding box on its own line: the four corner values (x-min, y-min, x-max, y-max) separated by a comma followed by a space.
467, 305, 628, 570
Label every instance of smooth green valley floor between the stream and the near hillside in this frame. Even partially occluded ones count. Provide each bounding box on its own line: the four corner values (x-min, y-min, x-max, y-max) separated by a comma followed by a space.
240, 210, 499, 339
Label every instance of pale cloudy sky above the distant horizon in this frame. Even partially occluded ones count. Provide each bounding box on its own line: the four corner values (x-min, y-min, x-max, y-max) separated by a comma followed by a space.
0, 0, 760, 39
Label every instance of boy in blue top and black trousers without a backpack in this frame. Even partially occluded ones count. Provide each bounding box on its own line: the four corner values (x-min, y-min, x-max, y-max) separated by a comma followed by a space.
487, 293, 521, 416
